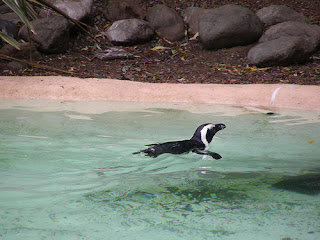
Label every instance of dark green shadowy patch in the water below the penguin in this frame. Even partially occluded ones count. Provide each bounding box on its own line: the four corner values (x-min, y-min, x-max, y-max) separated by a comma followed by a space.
86, 171, 282, 204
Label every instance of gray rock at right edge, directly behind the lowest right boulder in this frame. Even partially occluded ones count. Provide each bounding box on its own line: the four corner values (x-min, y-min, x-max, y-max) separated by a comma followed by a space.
259, 21, 320, 52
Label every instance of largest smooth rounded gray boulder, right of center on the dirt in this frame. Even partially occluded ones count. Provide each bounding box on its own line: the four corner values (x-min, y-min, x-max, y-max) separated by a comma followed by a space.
199, 4, 263, 49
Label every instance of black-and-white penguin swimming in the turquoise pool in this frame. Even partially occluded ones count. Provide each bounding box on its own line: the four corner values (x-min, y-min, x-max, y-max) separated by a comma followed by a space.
133, 123, 226, 160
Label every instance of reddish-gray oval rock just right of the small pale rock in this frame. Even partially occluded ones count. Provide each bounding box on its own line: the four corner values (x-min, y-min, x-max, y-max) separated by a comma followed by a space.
146, 4, 185, 42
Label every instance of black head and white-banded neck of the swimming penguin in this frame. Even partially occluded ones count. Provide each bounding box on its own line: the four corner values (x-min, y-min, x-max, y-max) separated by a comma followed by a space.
191, 123, 226, 148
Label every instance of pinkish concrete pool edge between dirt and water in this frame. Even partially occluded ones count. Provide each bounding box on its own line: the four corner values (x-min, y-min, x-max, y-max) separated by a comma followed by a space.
0, 76, 320, 111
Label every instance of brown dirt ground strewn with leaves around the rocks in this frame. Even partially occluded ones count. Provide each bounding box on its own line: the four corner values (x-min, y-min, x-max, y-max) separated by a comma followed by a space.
0, 0, 320, 85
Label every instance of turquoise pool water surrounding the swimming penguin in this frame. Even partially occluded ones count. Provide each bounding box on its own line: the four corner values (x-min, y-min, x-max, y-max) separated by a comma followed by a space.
0, 100, 320, 240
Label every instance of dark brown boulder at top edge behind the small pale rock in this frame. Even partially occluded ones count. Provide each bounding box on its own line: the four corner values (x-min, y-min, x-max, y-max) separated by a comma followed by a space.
103, 0, 146, 22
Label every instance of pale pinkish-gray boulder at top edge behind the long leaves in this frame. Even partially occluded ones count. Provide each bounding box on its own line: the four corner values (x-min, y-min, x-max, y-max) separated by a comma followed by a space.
40, 0, 93, 21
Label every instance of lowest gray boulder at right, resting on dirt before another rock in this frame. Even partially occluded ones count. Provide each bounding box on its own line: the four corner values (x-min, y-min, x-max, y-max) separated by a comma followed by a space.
248, 37, 311, 67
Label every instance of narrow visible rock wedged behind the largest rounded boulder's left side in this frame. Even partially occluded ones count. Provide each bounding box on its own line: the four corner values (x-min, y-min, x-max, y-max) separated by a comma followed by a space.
182, 7, 212, 35
